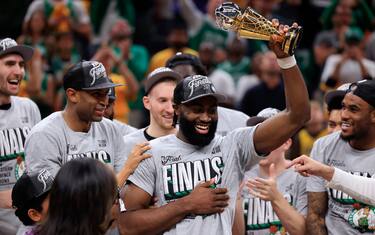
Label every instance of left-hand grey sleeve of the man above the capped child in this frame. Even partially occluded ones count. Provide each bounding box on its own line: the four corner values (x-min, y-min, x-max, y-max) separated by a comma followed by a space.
25, 132, 62, 176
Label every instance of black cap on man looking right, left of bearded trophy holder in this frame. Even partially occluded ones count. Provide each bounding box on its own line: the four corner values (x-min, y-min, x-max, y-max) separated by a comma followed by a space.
63, 61, 121, 90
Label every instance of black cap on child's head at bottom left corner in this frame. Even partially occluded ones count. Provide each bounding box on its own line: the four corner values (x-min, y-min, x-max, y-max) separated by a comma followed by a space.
12, 169, 53, 209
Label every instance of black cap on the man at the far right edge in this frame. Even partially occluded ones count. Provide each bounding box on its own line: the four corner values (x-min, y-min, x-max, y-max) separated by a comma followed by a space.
349, 80, 375, 107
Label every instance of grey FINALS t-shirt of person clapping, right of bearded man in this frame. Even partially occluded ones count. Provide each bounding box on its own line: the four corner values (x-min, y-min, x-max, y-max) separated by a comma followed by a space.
241, 166, 307, 235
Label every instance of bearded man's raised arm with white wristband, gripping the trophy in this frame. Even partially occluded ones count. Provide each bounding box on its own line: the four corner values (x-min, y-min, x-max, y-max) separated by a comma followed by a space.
254, 21, 310, 153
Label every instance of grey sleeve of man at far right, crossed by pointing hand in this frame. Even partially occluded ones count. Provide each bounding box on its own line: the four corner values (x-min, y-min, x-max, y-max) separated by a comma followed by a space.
306, 140, 327, 192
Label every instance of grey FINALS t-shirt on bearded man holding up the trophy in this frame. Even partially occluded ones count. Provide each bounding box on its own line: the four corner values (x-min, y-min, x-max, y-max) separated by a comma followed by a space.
129, 127, 261, 235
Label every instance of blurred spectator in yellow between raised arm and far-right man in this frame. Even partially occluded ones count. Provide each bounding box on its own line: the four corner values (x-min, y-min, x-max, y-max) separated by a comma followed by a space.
293, 101, 327, 156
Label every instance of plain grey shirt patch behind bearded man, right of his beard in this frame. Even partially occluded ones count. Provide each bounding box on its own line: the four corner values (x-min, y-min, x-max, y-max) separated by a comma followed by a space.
216, 107, 249, 136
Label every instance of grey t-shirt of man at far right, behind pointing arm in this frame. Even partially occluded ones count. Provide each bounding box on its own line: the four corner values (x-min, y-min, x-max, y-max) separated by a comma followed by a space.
307, 132, 375, 235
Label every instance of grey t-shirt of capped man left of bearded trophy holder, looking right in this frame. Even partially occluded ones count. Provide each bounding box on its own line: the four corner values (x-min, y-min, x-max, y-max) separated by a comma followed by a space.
25, 112, 125, 175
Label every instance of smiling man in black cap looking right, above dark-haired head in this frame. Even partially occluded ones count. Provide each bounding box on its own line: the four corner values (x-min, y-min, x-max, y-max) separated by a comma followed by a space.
25, 61, 125, 178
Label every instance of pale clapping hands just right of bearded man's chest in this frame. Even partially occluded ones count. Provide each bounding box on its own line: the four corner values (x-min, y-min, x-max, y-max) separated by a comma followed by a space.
246, 163, 283, 202
